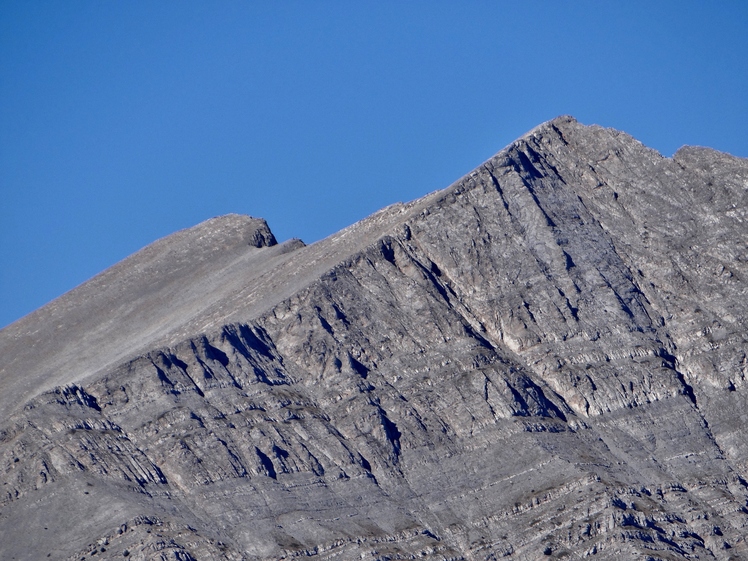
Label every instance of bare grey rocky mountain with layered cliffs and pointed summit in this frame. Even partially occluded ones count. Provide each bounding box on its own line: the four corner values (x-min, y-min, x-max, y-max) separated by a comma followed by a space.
0, 117, 748, 561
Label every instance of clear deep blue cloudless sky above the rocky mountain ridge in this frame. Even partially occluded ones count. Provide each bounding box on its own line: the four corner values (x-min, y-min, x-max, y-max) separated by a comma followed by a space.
0, 0, 748, 326
